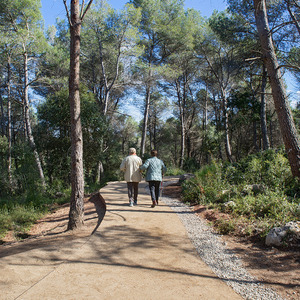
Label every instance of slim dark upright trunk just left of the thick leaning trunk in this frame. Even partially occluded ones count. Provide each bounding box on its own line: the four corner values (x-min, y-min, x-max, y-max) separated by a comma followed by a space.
260, 65, 270, 150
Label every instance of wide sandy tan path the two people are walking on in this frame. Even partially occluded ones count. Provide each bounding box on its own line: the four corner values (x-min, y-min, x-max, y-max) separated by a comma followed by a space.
0, 182, 241, 300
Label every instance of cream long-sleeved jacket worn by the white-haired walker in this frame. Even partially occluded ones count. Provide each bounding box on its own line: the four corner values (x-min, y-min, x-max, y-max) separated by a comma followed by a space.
120, 154, 143, 182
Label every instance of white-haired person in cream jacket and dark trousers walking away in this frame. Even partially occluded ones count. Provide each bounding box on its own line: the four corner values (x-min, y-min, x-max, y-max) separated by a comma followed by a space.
120, 148, 143, 206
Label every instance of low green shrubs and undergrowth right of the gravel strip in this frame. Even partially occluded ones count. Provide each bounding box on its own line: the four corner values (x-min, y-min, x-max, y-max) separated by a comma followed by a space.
182, 150, 300, 238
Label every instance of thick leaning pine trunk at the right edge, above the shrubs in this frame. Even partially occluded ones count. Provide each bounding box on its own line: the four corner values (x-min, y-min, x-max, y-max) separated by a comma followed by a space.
253, 0, 300, 178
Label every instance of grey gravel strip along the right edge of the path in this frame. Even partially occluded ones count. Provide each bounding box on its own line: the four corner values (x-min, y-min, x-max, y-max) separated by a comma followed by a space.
162, 197, 283, 300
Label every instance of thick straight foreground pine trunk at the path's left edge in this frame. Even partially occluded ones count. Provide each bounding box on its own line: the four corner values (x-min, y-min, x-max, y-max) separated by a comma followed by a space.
68, 0, 84, 230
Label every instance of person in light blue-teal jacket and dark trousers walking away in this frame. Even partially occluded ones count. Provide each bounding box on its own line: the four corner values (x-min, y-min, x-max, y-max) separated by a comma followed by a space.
140, 150, 167, 207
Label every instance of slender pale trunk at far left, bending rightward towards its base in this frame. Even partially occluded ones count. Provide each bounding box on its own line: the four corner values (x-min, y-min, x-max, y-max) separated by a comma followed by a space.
23, 47, 46, 189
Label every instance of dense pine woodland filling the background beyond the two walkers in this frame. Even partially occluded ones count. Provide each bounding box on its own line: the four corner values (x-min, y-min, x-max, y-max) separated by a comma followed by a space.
0, 0, 300, 233
